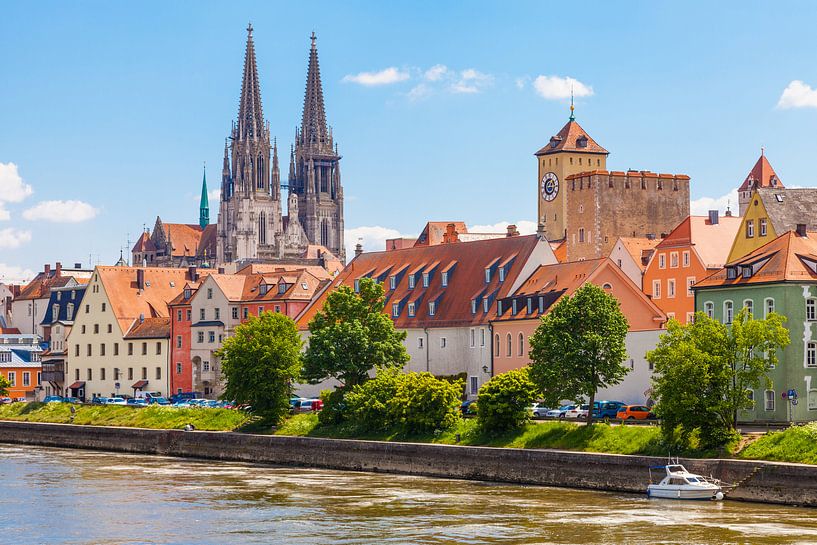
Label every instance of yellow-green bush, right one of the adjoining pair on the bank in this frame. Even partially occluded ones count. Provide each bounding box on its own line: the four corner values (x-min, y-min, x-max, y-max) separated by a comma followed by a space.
390, 373, 463, 433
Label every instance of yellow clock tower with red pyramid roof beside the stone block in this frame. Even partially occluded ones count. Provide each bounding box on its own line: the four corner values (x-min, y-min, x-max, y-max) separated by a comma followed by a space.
536, 105, 609, 240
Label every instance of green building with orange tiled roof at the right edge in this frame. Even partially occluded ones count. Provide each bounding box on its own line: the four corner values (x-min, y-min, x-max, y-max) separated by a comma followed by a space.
694, 228, 817, 421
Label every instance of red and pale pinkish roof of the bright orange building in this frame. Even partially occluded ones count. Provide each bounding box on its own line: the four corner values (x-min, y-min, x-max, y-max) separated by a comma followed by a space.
656, 216, 742, 269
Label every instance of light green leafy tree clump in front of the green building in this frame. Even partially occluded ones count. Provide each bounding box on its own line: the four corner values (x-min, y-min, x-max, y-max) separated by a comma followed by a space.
647, 308, 790, 448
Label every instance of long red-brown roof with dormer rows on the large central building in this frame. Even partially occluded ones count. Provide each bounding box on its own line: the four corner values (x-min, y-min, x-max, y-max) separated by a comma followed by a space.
296, 235, 555, 329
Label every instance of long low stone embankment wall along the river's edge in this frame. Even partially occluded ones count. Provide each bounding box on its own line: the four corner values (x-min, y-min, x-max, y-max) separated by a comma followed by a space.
0, 421, 817, 506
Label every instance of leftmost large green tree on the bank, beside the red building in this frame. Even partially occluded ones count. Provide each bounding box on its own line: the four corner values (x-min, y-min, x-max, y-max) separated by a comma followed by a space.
216, 312, 303, 424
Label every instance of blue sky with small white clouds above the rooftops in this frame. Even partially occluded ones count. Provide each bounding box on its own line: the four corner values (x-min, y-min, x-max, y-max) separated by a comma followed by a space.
0, 0, 817, 282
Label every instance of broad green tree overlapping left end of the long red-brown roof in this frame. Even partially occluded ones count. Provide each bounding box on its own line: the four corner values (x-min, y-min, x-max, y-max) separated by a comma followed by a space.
303, 278, 409, 390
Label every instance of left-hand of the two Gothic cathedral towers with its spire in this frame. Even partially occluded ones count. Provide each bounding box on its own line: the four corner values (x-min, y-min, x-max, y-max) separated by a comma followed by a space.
218, 25, 282, 263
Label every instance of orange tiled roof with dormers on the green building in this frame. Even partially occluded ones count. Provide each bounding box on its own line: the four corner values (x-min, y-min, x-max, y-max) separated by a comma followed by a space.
695, 231, 817, 288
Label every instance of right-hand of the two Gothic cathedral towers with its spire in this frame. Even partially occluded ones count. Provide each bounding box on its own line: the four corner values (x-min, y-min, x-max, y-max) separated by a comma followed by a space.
289, 32, 346, 261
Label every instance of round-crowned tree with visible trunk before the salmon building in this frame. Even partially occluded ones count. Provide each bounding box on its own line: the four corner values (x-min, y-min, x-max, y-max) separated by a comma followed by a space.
530, 283, 629, 424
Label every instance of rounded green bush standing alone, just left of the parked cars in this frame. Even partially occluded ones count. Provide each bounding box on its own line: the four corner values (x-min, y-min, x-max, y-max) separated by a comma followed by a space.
477, 367, 538, 433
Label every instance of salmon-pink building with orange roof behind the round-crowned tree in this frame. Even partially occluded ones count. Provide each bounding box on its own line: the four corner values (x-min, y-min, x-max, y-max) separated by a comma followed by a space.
490, 258, 666, 404
